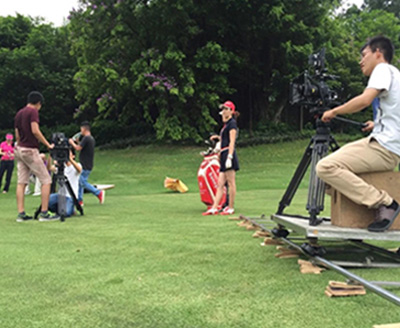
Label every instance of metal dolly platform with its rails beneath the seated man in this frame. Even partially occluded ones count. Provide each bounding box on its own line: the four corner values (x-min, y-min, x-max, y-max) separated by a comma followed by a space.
241, 214, 400, 306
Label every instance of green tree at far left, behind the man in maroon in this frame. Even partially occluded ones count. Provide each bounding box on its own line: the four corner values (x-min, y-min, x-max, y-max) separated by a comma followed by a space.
0, 15, 76, 129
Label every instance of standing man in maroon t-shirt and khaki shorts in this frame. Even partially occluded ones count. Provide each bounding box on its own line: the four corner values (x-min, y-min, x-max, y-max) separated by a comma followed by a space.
14, 91, 54, 222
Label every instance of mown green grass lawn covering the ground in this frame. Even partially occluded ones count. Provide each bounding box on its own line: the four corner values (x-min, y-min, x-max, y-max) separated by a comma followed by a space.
0, 140, 400, 328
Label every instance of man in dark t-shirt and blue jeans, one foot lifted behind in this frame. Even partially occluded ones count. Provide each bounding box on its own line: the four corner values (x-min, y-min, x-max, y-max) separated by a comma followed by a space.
69, 121, 105, 206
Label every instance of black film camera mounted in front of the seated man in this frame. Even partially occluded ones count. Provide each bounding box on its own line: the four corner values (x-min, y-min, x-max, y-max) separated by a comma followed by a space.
289, 48, 339, 113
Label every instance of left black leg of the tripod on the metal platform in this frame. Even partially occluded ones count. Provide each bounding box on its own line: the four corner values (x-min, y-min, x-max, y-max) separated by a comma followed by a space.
277, 140, 314, 214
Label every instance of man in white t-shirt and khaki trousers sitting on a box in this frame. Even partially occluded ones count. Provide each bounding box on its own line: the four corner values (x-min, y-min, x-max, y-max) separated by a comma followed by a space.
317, 36, 400, 232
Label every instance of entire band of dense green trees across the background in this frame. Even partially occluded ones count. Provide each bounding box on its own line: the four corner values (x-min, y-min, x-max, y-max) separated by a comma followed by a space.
0, 0, 400, 142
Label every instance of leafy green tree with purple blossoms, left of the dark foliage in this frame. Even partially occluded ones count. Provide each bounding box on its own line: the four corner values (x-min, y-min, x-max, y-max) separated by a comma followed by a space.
70, 1, 233, 140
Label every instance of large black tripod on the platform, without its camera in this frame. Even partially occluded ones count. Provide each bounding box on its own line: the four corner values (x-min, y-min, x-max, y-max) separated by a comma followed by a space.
277, 118, 339, 226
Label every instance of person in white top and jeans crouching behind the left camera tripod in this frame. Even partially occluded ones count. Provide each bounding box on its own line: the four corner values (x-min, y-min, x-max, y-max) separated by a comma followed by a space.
47, 149, 82, 221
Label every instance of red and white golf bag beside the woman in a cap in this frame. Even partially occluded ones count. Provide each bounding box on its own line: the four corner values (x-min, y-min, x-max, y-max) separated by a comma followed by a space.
197, 140, 228, 209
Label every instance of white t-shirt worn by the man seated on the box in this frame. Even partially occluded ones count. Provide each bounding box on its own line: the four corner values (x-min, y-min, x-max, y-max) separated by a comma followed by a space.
367, 63, 400, 156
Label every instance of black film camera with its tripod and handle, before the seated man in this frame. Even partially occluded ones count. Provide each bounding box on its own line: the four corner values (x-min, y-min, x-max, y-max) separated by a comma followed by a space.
277, 48, 364, 226
